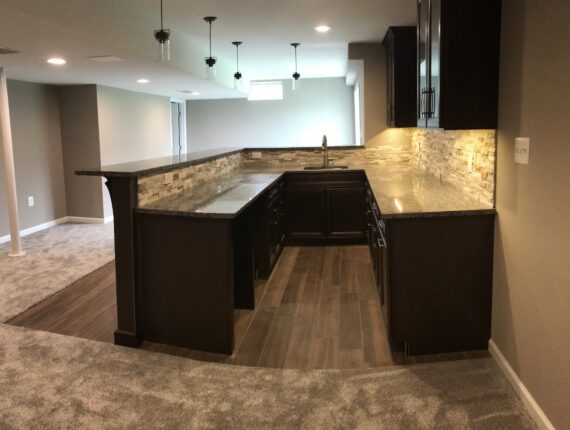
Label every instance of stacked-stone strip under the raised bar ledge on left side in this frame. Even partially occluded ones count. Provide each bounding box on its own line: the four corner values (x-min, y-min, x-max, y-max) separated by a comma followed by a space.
138, 153, 243, 206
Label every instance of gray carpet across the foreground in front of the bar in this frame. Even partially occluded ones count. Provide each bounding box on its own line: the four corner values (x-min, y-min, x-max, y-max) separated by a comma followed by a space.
0, 325, 536, 430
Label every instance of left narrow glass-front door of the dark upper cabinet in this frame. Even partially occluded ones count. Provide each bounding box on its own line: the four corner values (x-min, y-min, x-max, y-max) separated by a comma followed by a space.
417, 0, 430, 127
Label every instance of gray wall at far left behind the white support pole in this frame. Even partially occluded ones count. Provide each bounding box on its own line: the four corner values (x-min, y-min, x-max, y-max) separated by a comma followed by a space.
0, 80, 66, 237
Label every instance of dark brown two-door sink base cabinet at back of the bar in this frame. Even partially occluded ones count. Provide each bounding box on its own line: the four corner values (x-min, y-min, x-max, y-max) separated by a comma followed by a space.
285, 172, 366, 245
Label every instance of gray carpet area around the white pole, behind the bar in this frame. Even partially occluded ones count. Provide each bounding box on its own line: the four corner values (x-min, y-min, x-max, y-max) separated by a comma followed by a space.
0, 224, 115, 322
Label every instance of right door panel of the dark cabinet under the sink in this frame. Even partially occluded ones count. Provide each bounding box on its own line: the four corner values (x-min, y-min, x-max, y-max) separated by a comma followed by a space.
326, 187, 366, 237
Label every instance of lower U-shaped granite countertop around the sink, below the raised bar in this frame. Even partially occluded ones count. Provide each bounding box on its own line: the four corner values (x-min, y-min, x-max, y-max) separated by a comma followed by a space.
137, 166, 495, 218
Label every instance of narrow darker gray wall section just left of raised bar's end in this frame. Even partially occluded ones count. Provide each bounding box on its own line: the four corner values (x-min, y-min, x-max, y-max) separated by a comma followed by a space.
59, 85, 106, 218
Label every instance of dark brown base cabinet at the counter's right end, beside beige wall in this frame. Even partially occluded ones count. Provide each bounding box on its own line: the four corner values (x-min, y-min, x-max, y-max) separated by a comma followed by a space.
378, 215, 495, 355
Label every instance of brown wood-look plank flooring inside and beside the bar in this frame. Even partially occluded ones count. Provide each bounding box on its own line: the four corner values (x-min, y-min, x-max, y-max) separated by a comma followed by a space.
8, 246, 488, 369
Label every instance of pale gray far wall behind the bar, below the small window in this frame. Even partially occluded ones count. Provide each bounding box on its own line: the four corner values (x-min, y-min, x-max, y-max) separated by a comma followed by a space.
187, 78, 355, 151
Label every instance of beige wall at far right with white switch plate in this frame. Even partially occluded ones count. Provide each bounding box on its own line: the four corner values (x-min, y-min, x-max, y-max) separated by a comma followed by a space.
492, 0, 570, 429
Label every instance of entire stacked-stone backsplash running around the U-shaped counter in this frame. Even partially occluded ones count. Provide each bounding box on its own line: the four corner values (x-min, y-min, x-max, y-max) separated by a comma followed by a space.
138, 129, 496, 206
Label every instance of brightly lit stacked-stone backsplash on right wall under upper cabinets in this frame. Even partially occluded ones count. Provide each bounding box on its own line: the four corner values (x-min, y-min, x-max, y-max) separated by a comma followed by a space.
410, 129, 496, 205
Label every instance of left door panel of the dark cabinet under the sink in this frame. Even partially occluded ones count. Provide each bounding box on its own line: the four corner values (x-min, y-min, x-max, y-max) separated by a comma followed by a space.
286, 187, 325, 238
